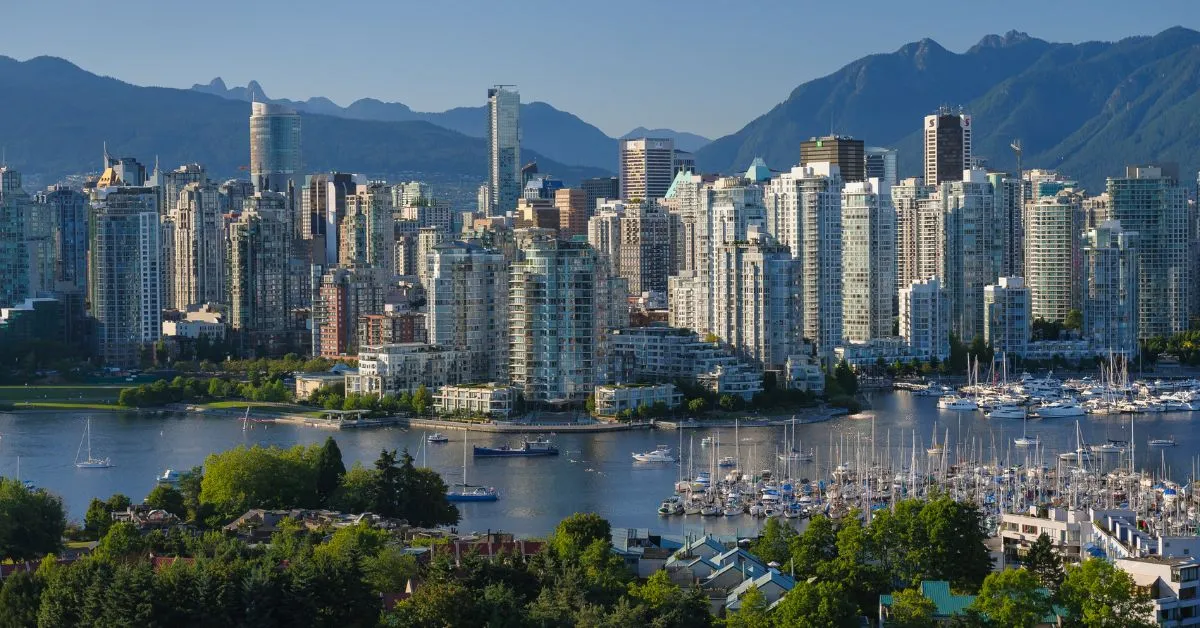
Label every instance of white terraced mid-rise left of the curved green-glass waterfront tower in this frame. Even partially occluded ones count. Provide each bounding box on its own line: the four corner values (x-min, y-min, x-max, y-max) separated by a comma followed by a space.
346, 342, 469, 397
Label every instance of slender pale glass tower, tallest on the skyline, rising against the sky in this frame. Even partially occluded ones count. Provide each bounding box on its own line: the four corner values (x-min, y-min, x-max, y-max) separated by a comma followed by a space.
487, 85, 523, 216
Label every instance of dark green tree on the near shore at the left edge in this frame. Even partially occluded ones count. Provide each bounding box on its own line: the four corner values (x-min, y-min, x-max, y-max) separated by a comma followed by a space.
0, 478, 67, 561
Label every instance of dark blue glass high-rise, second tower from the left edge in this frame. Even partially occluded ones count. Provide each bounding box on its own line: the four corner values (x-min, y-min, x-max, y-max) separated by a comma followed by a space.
35, 185, 88, 293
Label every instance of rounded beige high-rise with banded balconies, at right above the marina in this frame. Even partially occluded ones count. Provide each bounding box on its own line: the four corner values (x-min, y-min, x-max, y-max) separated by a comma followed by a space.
1025, 191, 1084, 322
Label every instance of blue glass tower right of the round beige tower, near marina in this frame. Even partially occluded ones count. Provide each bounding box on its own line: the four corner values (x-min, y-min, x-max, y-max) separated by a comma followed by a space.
1084, 221, 1138, 357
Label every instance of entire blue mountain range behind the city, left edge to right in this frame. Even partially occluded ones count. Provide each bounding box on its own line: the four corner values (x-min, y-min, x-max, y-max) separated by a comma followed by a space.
0, 28, 1200, 191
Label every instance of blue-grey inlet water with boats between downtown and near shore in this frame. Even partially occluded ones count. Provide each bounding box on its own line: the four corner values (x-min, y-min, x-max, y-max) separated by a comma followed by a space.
0, 393, 1200, 536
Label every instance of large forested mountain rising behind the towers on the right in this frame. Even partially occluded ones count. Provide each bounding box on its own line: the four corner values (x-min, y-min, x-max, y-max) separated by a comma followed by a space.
696, 28, 1200, 191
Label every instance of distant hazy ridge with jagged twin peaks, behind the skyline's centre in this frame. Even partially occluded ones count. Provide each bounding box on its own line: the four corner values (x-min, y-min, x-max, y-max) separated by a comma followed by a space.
192, 77, 709, 171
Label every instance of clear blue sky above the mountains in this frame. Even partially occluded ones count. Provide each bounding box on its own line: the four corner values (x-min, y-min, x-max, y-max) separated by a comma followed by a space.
0, 0, 1200, 137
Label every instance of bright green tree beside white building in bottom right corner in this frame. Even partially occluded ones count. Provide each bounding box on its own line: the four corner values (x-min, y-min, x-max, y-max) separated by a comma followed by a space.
1058, 558, 1154, 628
